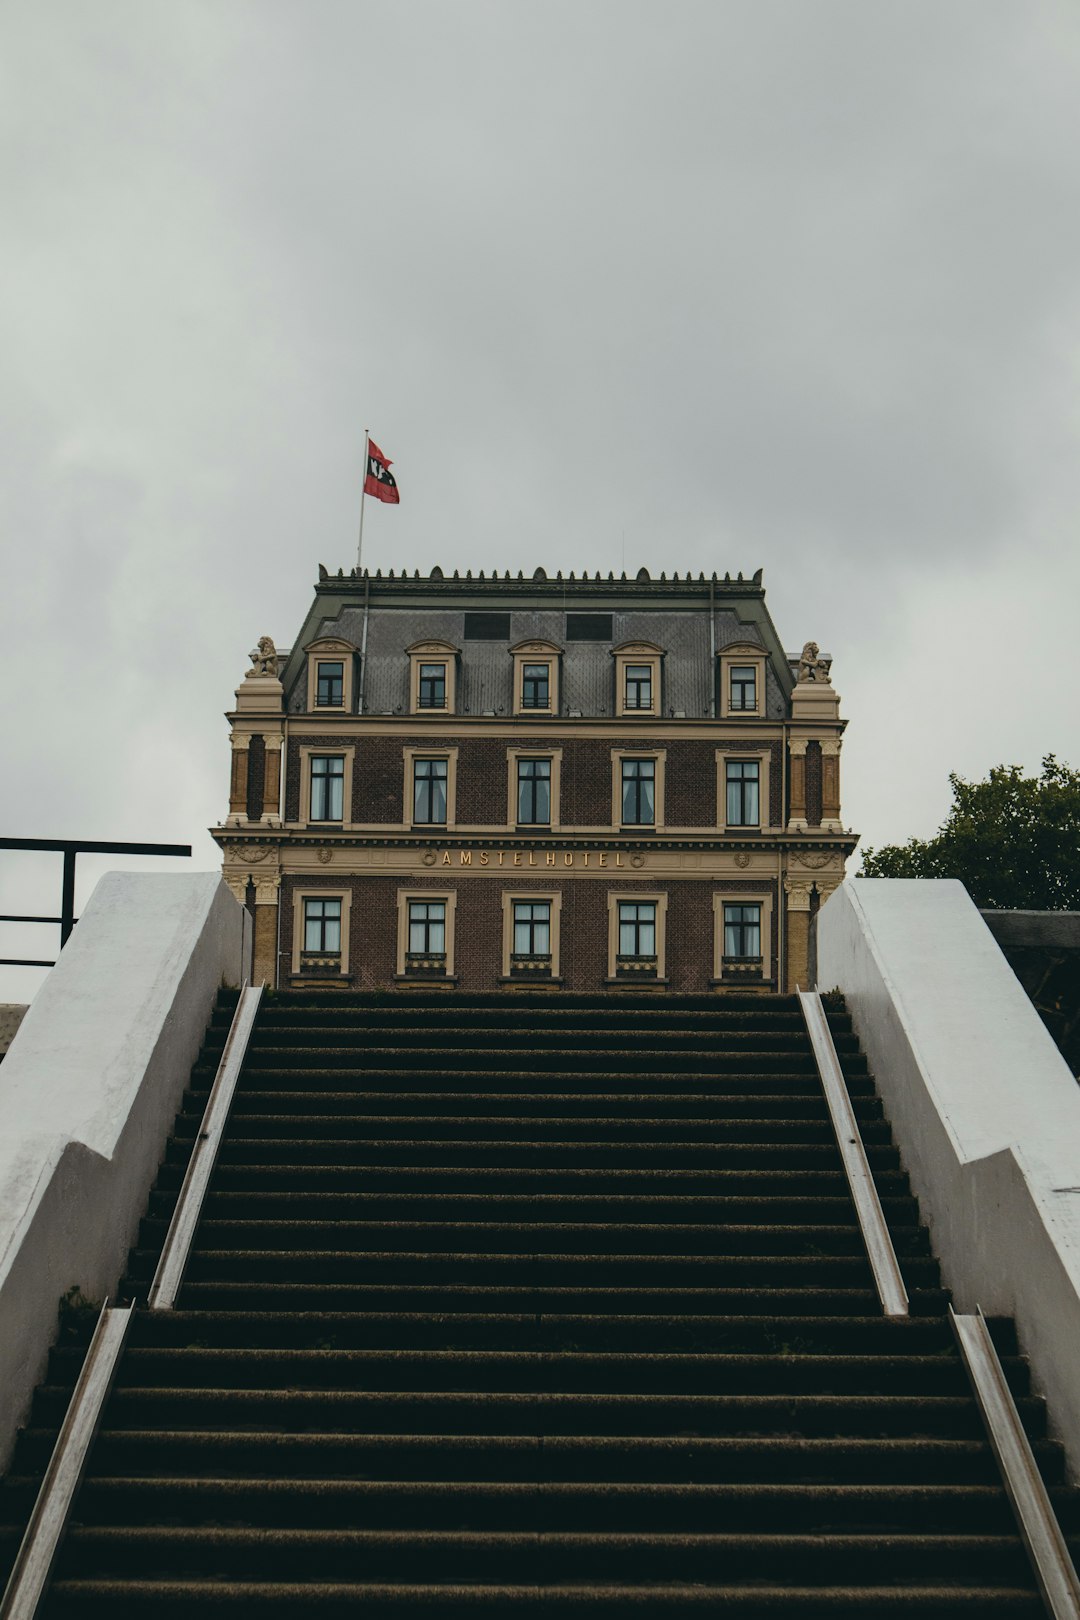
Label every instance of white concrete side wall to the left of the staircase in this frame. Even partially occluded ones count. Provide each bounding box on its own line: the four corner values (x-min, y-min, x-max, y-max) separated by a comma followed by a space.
0, 872, 248, 1468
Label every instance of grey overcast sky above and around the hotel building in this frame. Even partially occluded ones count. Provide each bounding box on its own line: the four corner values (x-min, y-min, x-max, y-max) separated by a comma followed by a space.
0, 0, 1080, 1000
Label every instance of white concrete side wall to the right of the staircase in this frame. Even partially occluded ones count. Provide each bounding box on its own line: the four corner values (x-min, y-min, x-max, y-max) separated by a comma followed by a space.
818, 878, 1080, 1479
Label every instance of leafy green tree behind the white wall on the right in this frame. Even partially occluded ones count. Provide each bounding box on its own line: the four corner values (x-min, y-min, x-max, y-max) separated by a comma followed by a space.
858, 753, 1080, 910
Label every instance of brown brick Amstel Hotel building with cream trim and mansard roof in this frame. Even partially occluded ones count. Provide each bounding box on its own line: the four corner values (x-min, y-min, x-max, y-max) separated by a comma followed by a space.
212, 569, 857, 993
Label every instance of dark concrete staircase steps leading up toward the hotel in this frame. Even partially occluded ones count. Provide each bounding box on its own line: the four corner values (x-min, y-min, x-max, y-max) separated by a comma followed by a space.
0, 991, 1080, 1620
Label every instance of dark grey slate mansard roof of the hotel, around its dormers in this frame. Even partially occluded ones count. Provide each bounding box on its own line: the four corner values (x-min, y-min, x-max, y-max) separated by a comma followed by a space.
282, 575, 792, 719
